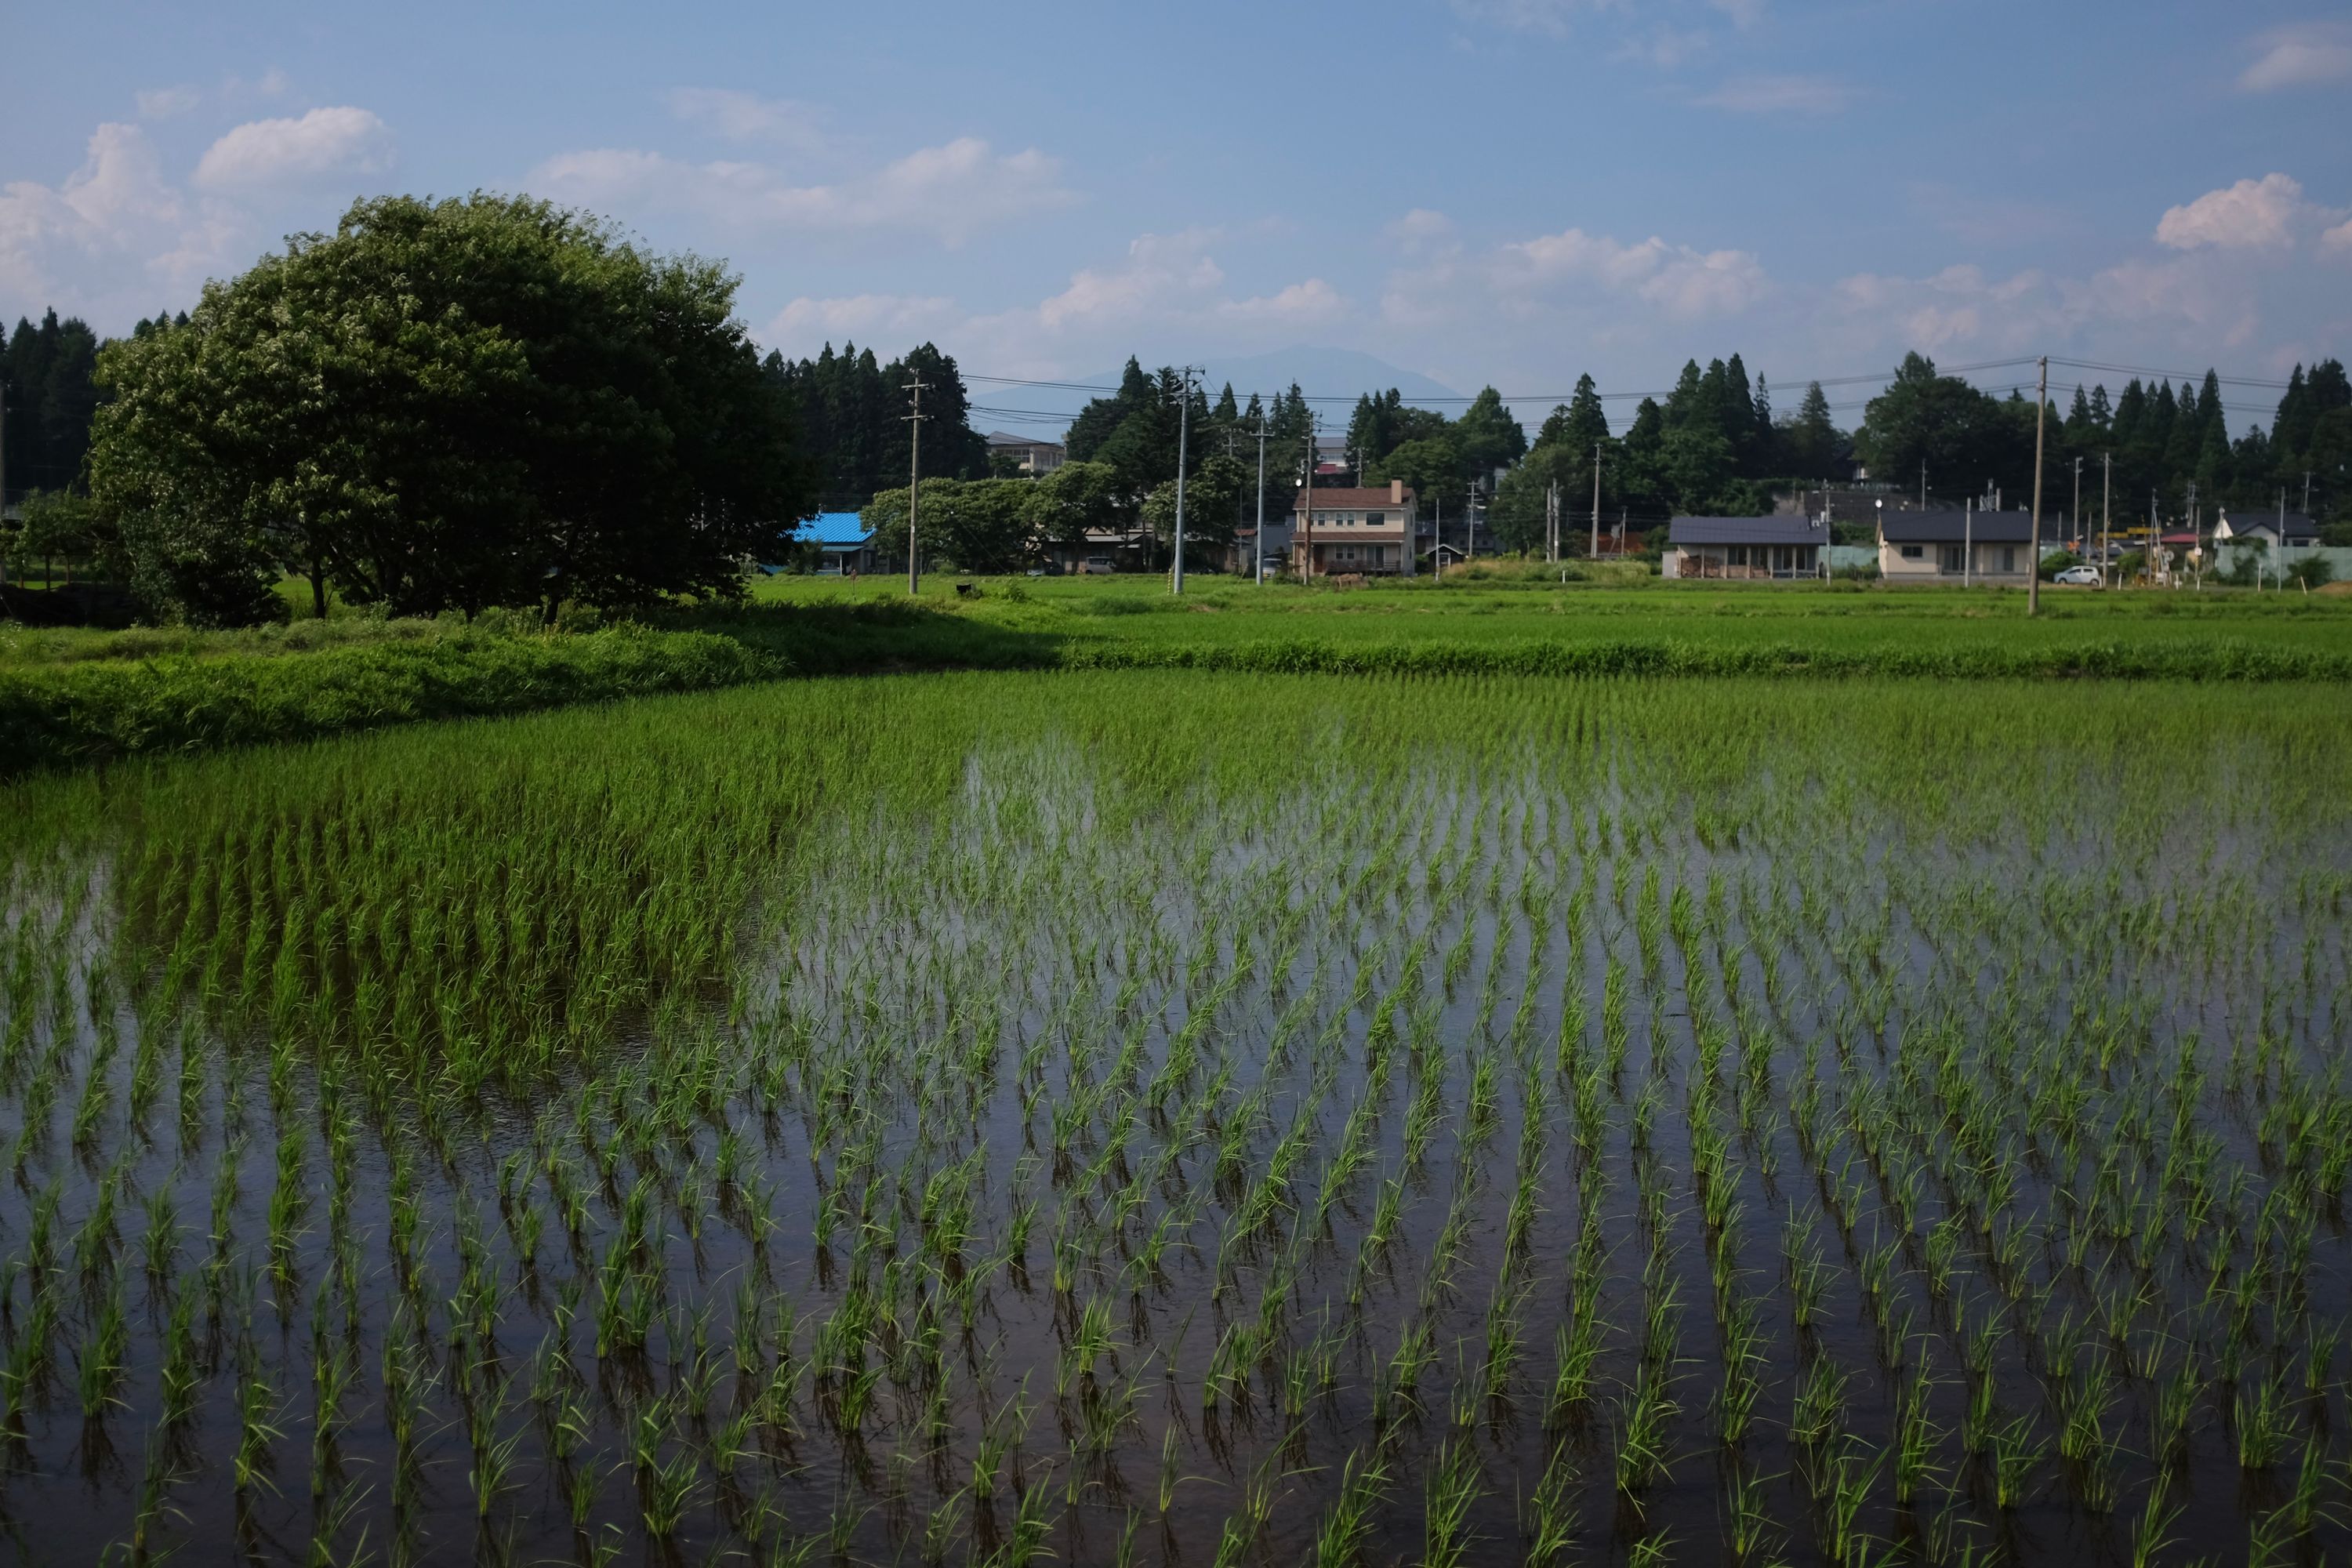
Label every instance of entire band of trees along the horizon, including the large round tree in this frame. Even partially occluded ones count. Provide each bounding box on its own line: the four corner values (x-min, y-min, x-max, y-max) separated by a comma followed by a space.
0, 195, 2352, 623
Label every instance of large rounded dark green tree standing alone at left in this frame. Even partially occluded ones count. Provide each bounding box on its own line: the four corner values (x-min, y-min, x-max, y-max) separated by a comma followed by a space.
89, 195, 814, 621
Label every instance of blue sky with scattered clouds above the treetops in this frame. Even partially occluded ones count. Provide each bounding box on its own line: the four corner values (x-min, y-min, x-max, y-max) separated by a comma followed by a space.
0, 0, 2352, 423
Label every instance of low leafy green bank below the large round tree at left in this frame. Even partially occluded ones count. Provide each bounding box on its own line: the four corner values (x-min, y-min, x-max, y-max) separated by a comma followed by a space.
0, 628, 790, 776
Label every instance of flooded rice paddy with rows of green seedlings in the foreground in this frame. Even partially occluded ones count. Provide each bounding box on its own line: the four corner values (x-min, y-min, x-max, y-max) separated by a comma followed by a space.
0, 673, 2352, 1568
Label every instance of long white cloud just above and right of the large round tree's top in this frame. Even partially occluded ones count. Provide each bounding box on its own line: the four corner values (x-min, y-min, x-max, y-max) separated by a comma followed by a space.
532, 136, 1075, 245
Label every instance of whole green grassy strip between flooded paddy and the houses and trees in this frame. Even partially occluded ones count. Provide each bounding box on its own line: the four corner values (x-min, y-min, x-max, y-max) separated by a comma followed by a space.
0, 572, 2352, 774
